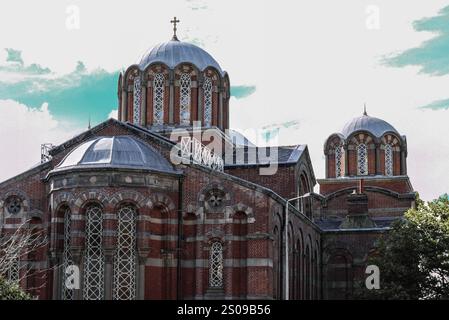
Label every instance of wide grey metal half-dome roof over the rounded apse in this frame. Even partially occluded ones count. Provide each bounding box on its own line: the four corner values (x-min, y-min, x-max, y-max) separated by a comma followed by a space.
56, 136, 174, 172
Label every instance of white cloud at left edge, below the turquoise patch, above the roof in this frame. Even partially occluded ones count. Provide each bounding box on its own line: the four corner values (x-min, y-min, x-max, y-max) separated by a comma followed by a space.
0, 100, 80, 181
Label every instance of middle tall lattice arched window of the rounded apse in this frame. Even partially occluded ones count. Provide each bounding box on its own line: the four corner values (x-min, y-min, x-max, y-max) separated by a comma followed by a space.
83, 205, 104, 300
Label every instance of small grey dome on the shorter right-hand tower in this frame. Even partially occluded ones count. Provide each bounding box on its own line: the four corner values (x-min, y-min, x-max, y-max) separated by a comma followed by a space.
341, 113, 399, 138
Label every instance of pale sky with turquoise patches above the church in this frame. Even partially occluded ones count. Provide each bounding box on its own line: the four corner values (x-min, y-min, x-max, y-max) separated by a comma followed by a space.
0, 0, 449, 200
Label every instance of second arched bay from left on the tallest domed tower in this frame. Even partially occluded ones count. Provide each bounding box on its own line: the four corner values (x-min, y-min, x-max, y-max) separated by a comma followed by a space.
144, 62, 174, 126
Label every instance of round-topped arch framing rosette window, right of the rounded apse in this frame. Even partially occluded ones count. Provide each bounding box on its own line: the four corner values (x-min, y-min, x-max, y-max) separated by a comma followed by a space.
197, 183, 232, 214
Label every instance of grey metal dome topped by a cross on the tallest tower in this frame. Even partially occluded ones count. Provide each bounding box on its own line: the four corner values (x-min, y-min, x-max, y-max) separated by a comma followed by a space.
139, 39, 223, 75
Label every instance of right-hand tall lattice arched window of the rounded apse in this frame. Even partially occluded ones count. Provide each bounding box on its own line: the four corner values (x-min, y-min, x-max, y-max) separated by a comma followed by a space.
113, 205, 137, 300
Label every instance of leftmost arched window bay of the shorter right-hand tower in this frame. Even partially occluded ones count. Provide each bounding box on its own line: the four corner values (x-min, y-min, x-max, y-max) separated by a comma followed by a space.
324, 133, 347, 178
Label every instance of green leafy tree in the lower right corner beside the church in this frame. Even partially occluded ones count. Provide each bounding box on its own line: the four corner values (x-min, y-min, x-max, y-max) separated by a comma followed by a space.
358, 196, 449, 299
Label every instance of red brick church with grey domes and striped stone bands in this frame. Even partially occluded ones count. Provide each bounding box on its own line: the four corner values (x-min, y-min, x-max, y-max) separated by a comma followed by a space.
0, 18, 415, 300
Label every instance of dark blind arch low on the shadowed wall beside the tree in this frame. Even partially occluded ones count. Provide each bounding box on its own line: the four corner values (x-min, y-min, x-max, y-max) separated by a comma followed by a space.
322, 245, 354, 299
